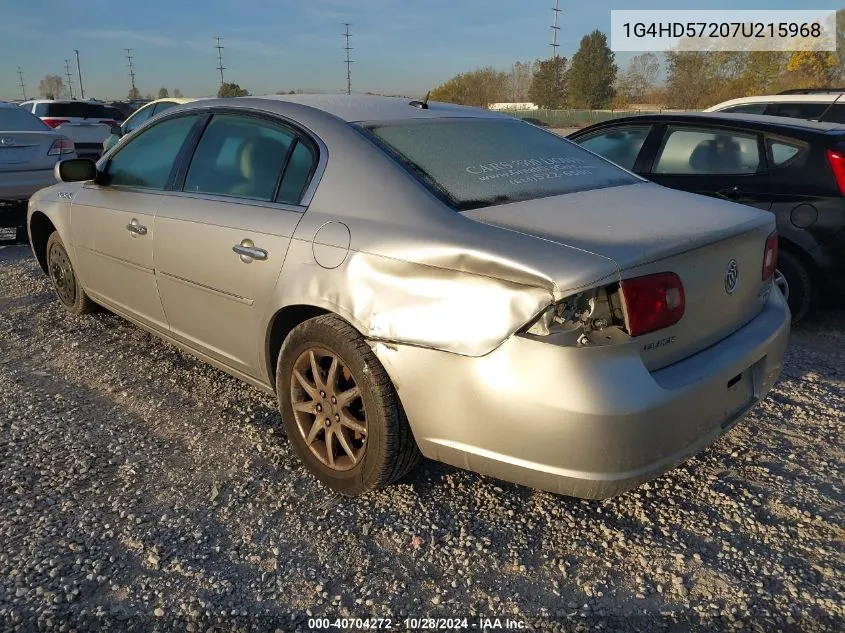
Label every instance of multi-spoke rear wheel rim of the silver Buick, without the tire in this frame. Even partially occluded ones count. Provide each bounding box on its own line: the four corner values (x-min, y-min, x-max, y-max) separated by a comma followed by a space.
290, 347, 368, 471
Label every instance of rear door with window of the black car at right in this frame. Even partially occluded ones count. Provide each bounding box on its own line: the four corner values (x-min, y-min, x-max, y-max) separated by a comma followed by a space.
641, 124, 772, 210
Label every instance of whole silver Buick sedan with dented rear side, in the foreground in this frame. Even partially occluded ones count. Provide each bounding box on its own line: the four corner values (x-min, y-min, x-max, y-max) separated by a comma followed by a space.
28, 95, 789, 498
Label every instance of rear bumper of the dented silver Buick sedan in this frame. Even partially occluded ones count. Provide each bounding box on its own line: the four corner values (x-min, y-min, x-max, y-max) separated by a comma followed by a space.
373, 292, 790, 499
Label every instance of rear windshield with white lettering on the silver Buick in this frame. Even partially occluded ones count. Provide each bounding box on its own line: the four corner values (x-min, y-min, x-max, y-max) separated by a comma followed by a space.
364, 119, 638, 210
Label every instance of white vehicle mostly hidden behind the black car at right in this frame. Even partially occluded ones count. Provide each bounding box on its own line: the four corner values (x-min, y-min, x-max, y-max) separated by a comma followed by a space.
705, 88, 845, 123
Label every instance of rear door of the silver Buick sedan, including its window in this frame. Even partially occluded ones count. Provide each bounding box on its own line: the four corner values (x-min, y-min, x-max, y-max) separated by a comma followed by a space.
155, 112, 317, 379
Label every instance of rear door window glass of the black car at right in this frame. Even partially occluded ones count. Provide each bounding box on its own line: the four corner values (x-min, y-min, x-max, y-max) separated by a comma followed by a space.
652, 128, 760, 175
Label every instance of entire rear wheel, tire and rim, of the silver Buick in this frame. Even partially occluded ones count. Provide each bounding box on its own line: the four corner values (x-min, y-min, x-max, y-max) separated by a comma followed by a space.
276, 315, 420, 496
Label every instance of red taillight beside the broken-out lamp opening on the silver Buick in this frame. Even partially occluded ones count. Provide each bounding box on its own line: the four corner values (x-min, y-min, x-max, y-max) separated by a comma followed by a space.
619, 273, 685, 336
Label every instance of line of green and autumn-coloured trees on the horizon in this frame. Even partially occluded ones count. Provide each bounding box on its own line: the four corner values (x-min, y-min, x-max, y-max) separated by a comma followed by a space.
431, 9, 845, 110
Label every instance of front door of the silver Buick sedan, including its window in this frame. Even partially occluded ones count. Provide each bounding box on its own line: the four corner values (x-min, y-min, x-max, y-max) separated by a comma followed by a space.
71, 115, 200, 330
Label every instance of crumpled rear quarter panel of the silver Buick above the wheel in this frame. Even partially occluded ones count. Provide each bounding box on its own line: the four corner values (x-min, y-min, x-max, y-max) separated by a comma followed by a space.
266, 117, 618, 356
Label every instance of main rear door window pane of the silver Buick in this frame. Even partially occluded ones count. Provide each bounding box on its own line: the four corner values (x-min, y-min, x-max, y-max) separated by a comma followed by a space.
184, 114, 295, 202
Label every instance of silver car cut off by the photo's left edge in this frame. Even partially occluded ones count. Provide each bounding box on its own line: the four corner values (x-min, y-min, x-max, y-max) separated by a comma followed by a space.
0, 102, 75, 241
